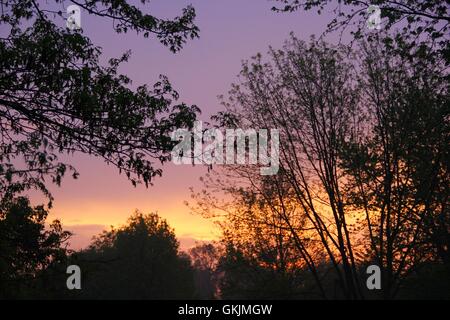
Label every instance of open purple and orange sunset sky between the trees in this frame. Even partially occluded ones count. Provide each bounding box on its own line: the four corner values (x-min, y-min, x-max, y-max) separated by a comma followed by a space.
44, 0, 340, 249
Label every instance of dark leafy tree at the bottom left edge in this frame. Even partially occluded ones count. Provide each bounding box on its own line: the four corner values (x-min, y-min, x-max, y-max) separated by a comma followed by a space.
0, 197, 71, 299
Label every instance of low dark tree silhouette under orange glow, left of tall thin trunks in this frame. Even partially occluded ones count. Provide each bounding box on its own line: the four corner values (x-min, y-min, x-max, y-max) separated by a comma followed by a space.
217, 239, 312, 299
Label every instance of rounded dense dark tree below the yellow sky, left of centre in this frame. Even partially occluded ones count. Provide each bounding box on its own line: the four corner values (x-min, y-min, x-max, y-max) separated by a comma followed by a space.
71, 212, 194, 299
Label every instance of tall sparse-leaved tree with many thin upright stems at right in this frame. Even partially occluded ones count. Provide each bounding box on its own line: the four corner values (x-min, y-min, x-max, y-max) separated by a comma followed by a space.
196, 37, 449, 299
